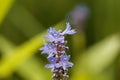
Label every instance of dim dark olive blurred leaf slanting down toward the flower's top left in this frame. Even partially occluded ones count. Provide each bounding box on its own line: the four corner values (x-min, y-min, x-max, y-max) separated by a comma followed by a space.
7, 2, 45, 38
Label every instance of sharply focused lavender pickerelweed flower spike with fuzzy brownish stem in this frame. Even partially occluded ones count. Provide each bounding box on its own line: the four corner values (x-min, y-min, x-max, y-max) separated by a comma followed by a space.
40, 23, 76, 80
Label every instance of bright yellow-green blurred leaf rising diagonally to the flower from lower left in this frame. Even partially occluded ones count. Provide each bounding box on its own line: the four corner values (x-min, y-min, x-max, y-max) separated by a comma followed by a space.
0, 34, 44, 76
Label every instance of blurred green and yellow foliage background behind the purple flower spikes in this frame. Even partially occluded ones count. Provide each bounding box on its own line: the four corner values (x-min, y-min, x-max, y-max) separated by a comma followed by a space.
0, 0, 120, 80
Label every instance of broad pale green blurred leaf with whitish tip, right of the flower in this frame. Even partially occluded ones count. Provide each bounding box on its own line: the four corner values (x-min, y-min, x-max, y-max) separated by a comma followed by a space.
71, 34, 120, 80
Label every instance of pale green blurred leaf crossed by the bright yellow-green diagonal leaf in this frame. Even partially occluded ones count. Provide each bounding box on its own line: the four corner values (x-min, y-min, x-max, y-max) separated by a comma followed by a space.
0, 36, 49, 80
